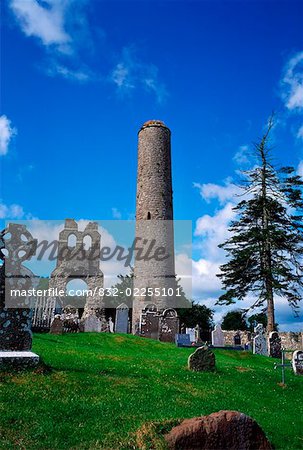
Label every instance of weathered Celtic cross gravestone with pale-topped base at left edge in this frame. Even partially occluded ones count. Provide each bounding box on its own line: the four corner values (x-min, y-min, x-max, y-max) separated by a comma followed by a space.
0, 223, 39, 368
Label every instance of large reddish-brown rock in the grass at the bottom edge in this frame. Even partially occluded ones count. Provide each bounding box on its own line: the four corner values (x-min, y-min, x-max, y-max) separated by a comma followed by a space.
164, 411, 273, 450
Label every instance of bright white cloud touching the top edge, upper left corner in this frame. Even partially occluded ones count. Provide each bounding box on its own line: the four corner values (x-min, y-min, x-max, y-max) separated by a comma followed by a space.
10, 0, 72, 53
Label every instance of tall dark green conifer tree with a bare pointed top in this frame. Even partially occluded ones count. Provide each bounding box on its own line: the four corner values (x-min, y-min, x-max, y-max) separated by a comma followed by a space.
217, 117, 303, 331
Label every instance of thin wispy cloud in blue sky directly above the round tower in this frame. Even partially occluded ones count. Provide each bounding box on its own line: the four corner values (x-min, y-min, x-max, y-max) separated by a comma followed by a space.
109, 47, 167, 103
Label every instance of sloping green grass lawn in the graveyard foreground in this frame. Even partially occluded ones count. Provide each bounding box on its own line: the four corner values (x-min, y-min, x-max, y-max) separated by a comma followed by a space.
0, 333, 303, 450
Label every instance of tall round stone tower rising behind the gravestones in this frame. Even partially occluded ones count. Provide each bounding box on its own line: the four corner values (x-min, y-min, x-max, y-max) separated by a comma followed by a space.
132, 120, 175, 333
